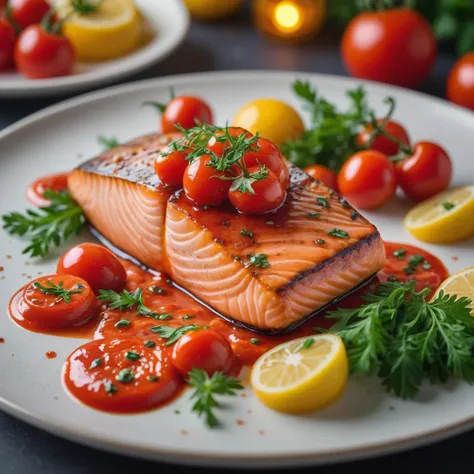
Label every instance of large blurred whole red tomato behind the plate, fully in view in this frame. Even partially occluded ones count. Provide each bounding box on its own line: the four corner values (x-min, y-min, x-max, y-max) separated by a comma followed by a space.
341, 8, 437, 87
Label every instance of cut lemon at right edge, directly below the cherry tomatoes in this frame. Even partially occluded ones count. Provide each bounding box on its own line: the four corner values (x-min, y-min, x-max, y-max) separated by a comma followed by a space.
404, 186, 474, 244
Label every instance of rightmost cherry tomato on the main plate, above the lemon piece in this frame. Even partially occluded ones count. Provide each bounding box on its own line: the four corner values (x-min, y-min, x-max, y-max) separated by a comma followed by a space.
397, 142, 453, 201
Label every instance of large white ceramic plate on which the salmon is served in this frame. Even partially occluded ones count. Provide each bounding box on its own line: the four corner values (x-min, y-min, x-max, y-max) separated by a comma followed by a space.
0, 72, 474, 467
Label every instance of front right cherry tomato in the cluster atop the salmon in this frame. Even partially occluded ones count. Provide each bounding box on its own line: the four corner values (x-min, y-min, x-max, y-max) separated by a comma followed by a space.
229, 166, 286, 215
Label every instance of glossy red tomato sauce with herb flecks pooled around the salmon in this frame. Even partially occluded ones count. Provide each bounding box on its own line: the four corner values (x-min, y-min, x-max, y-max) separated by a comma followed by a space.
10, 243, 448, 413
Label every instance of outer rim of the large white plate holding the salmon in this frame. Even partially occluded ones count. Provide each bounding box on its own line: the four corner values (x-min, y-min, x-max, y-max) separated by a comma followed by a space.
0, 70, 474, 468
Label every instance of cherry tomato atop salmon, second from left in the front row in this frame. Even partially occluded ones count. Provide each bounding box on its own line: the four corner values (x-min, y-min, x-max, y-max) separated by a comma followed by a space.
183, 155, 232, 206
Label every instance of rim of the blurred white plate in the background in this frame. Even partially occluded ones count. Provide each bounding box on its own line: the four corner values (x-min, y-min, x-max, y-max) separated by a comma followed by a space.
0, 0, 191, 99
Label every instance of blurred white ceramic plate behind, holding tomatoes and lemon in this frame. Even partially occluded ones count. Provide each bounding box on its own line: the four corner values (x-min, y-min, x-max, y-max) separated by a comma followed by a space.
0, 0, 189, 99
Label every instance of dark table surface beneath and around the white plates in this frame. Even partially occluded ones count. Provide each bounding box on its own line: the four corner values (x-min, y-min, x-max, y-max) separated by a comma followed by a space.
0, 10, 474, 474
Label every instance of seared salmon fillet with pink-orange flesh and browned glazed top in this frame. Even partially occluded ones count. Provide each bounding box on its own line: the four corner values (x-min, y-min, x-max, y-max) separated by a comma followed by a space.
69, 131, 385, 332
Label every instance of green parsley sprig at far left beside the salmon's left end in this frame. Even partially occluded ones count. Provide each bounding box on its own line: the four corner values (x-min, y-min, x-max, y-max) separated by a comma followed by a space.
2, 190, 86, 257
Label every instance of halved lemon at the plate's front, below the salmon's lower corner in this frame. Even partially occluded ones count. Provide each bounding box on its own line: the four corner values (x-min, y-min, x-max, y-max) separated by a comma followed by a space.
251, 334, 349, 413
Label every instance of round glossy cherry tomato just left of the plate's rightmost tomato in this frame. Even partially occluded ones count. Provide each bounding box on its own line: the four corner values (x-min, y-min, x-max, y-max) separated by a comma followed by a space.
338, 150, 397, 209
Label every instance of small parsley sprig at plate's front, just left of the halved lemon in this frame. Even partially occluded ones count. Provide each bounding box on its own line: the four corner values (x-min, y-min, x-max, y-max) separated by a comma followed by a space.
187, 369, 243, 427
